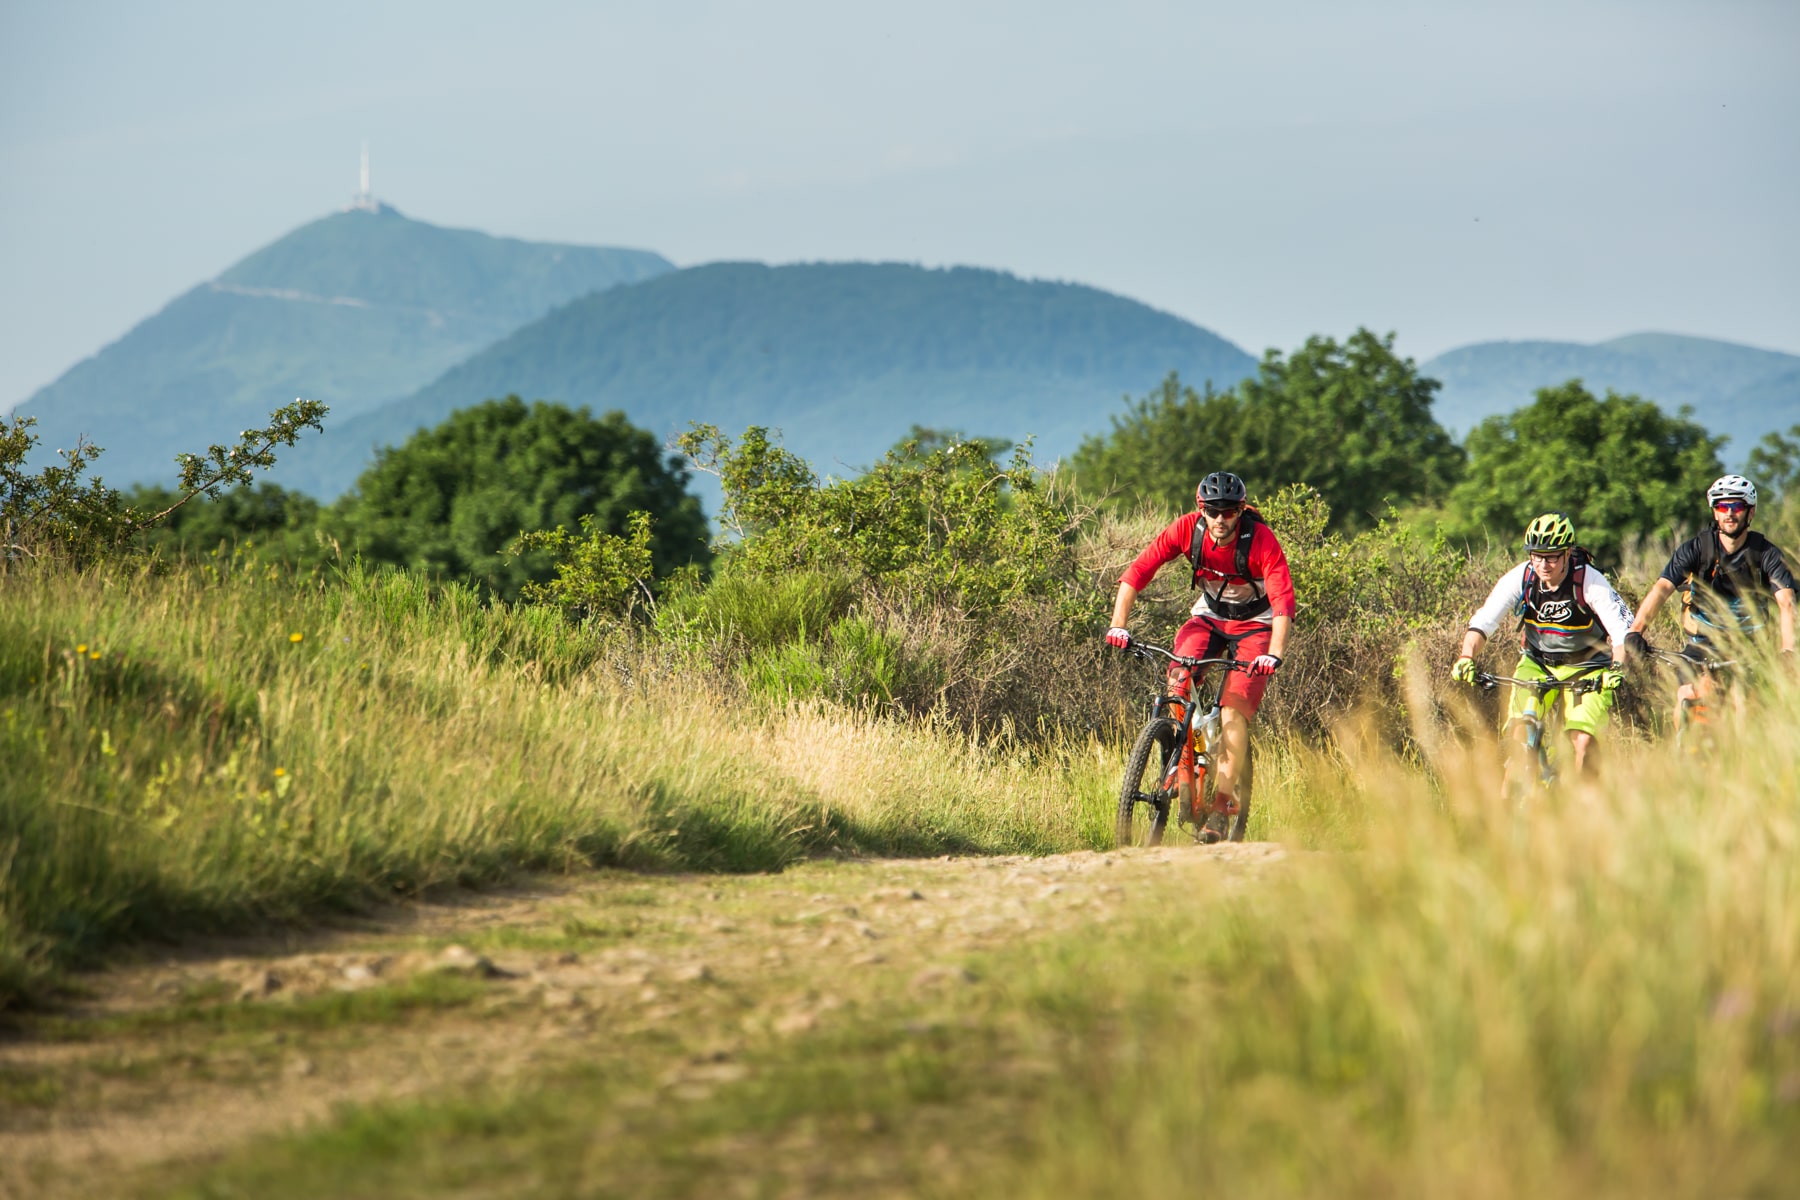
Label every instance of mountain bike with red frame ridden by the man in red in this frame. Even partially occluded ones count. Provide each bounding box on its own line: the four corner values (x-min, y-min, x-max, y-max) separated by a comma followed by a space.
1114, 640, 1249, 847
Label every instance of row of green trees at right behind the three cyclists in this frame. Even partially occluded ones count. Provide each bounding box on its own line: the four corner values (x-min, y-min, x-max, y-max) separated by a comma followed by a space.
1071, 329, 1778, 554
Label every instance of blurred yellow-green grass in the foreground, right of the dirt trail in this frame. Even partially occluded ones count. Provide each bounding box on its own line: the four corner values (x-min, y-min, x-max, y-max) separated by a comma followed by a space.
151, 708, 1800, 1198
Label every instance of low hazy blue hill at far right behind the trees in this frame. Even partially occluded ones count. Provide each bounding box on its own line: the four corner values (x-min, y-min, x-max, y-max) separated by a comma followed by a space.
1422, 333, 1800, 462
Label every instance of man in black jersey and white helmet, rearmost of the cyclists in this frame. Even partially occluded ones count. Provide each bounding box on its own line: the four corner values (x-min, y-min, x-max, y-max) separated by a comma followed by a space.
1625, 475, 1795, 719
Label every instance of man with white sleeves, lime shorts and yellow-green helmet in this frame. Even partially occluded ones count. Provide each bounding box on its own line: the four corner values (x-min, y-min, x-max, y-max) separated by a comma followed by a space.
1451, 513, 1631, 781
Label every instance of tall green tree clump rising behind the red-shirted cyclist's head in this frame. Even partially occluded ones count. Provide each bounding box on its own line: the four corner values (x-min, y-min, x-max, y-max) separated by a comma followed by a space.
1073, 329, 1463, 531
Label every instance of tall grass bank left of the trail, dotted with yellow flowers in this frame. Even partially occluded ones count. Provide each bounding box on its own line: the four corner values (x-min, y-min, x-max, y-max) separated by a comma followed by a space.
0, 569, 1114, 1006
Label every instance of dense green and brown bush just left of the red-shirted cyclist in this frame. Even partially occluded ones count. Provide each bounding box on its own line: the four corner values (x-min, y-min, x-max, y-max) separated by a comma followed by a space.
673, 426, 1107, 727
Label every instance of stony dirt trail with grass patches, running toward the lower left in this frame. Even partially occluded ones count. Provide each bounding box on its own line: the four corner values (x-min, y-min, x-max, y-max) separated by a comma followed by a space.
0, 844, 1283, 1196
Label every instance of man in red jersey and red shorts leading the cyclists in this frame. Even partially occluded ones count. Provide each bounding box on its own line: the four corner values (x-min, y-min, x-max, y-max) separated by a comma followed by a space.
1105, 471, 1294, 842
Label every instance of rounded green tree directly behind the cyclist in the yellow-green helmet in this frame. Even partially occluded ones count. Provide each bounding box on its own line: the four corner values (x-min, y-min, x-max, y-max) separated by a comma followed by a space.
1449, 380, 1724, 556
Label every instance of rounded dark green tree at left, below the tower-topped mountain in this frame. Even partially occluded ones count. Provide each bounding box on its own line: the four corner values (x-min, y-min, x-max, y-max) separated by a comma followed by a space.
337, 396, 709, 599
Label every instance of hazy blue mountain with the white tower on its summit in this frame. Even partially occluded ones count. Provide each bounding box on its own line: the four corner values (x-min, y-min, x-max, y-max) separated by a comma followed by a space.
18, 205, 673, 484
